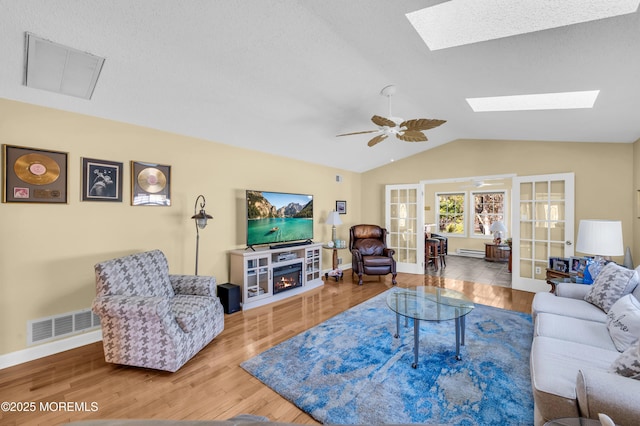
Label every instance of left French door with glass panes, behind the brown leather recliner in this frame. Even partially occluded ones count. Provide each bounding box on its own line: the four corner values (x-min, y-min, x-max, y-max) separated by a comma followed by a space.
385, 185, 424, 274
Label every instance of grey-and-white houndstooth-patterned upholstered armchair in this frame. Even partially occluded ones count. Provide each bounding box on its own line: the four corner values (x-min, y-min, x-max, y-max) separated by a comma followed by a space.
92, 250, 224, 372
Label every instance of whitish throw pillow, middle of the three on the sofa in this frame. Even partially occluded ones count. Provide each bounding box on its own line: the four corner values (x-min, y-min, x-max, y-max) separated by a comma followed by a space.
607, 294, 640, 352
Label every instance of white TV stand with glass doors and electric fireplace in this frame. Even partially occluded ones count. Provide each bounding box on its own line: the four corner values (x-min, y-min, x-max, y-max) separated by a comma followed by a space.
230, 243, 324, 310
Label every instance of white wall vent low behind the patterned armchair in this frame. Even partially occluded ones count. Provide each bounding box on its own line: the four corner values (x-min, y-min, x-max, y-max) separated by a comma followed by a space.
27, 309, 100, 345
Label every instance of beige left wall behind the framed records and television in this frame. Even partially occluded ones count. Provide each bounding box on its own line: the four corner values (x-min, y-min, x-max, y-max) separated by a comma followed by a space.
0, 100, 361, 354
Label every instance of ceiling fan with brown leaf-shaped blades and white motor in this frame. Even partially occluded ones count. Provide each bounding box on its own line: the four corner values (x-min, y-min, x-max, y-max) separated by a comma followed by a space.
337, 84, 446, 146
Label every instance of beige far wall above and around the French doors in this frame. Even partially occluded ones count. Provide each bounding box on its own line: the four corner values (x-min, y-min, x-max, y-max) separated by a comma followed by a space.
362, 140, 640, 261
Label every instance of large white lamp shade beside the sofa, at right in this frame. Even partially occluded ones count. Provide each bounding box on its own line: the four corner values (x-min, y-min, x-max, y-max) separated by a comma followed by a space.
576, 219, 624, 256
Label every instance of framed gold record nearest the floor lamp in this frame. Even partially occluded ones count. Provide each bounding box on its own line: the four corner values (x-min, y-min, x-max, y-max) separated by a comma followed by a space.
131, 161, 171, 206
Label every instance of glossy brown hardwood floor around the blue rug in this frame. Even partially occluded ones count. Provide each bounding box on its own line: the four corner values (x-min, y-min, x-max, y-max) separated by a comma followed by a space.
0, 271, 533, 425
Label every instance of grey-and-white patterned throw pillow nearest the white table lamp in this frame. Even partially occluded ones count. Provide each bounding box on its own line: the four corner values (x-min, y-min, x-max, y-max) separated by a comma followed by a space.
584, 262, 638, 313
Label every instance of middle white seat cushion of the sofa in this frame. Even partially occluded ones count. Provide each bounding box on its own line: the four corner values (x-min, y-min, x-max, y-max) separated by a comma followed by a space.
533, 312, 616, 351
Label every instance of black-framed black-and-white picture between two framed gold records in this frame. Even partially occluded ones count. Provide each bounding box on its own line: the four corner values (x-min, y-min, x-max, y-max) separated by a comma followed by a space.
82, 158, 123, 202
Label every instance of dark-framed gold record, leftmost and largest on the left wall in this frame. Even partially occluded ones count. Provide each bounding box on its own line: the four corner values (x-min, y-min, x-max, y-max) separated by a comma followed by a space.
2, 145, 67, 204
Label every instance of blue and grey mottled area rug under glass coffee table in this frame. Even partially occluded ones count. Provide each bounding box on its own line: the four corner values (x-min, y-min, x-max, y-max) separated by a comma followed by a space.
241, 292, 533, 425
